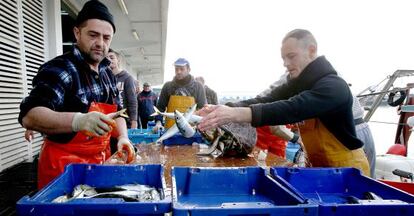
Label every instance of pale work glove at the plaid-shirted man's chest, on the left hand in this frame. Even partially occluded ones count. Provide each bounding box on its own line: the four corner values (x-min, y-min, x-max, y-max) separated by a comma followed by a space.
72, 111, 116, 136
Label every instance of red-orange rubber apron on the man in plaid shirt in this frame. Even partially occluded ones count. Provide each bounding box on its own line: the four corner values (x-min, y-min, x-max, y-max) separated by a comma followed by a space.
37, 102, 117, 189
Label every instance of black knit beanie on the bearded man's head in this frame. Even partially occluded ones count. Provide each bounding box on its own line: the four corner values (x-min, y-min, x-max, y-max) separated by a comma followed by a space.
75, 0, 116, 33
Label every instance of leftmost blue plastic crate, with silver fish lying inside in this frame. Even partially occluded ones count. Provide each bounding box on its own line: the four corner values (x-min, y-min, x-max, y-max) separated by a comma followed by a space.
16, 164, 171, 215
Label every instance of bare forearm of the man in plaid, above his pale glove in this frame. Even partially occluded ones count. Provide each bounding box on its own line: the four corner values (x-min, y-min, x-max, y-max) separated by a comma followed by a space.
22, 107, 75, 134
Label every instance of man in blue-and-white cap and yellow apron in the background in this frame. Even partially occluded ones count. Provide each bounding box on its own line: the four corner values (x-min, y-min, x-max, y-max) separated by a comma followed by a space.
153, 58, 207, 132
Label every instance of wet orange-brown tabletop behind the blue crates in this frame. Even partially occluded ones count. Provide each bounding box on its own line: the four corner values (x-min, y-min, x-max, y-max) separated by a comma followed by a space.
135, 144, 293, 189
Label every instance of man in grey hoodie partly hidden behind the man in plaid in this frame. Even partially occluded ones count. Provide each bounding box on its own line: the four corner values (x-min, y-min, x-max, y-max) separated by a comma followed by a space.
108, 49, 138, 128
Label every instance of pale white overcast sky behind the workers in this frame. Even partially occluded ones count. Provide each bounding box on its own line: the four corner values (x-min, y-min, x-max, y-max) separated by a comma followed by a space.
164, 0, 414, 96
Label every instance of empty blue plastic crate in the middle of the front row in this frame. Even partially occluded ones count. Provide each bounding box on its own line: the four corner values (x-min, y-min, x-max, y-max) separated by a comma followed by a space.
172, 167, 318, 216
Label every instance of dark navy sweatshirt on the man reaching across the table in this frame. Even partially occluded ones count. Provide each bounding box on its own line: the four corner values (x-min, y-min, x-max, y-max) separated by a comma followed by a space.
235, 56, 363, 150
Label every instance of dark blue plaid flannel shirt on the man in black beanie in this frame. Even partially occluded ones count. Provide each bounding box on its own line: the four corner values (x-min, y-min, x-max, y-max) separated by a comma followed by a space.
19, 46, 121, 143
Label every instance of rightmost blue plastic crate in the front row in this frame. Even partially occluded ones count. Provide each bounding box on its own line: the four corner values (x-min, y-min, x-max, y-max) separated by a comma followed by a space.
270, 167, 414, 216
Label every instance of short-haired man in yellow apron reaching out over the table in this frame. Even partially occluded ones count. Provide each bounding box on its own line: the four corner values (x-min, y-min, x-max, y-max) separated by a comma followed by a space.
198, 29, 369, 176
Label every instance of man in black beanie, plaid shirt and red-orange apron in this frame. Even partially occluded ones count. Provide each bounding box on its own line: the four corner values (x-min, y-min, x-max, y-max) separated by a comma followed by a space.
19, 0, 135, 189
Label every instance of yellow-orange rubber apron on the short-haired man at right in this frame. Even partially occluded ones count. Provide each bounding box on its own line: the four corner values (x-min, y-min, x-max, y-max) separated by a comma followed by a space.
299, 119, 370, 176
